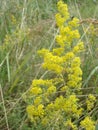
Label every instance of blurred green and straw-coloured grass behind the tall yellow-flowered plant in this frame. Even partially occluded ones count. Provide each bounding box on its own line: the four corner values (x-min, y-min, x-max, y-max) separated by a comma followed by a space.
0, 0, 98, 130
